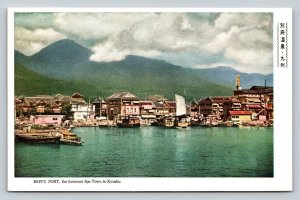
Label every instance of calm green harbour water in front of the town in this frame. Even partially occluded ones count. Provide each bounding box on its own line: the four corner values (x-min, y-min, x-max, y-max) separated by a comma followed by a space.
15, 127, 273, 177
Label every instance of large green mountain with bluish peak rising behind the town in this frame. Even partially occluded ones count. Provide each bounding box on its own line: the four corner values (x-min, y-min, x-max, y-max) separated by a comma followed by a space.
15, 39, 272, 100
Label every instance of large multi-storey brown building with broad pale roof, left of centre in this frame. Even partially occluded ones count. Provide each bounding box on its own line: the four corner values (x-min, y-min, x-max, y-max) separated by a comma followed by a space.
106, 92, 140, 122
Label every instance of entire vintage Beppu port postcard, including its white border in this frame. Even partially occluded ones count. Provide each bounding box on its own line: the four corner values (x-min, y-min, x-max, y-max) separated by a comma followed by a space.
7, 8, 292, 191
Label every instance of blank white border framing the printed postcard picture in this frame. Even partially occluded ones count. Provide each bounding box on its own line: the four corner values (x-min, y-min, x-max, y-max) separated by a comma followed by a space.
7, 8, 292, 191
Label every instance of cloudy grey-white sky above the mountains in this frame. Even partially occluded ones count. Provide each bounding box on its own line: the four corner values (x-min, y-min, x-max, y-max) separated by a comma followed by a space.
15, 13, 273, 74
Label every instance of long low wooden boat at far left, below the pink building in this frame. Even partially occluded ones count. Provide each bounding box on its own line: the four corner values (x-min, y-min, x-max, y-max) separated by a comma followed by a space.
15, 132, 62, 143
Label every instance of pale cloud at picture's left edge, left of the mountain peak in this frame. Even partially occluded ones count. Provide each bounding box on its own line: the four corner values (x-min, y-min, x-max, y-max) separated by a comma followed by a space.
15, 27, 65, 55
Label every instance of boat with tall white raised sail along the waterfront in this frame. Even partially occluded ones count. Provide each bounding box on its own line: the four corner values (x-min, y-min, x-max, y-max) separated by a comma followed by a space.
175, 94, 190, 128
